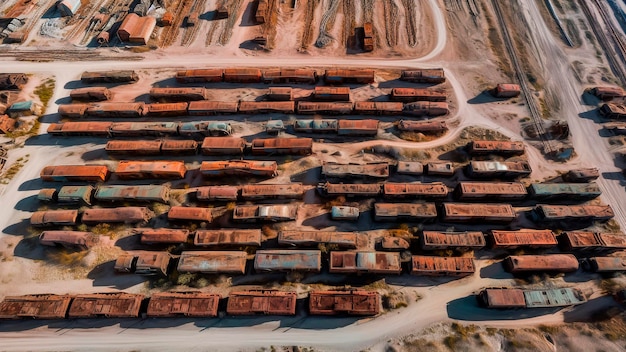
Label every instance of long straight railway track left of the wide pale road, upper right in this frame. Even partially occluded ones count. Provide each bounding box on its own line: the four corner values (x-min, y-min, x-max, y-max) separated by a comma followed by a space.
491, 0, 552, 154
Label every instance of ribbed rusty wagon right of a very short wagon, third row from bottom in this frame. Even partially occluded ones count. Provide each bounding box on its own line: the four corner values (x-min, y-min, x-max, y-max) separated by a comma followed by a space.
419, 231, 485, 251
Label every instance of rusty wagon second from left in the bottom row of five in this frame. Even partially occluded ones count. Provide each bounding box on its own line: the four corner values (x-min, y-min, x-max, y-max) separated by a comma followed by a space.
68, 292, 144, 318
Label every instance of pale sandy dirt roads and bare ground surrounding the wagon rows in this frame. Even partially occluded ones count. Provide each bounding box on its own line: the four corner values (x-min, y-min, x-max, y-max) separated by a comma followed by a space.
0, 0, 626, 351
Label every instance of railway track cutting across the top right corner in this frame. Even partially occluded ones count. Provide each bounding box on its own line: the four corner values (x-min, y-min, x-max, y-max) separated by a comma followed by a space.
579, 0, 626, 85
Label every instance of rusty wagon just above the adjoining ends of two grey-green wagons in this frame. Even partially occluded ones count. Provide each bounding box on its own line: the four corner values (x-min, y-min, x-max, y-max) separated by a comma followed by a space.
193, 229, 262, 247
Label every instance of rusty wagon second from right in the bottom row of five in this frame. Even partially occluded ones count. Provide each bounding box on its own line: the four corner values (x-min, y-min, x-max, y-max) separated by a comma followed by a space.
226, 290, 298, 315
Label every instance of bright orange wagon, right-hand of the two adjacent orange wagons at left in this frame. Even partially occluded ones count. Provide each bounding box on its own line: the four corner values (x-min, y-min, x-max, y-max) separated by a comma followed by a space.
115, 160, 187, 180
